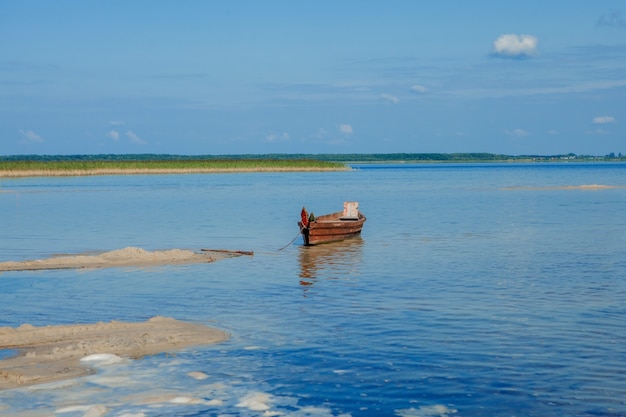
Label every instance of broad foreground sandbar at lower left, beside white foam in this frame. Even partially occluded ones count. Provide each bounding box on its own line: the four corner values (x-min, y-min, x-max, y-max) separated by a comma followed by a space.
0, 316, 229, 390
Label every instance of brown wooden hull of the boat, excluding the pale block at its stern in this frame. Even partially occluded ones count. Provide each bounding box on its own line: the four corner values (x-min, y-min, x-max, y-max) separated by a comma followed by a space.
298, 212, 366, 246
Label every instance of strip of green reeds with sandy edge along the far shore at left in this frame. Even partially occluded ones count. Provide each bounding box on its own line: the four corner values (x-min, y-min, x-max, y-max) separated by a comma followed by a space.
0, 159, 347, 177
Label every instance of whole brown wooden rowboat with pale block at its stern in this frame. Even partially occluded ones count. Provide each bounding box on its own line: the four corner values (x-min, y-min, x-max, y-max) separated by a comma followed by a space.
298, 201, 366, 246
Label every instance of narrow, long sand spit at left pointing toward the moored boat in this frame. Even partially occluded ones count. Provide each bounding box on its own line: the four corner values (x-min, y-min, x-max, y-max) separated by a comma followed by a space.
0, 247, 252, 272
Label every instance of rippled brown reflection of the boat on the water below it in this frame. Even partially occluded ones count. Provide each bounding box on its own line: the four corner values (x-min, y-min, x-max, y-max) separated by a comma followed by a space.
299, 237, 363, 286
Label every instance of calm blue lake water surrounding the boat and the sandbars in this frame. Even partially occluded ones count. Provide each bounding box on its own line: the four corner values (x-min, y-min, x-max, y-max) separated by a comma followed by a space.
0, 164, 626, 417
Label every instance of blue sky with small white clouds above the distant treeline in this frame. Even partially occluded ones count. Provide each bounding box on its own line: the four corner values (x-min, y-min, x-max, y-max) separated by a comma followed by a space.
0, 0, 626, 155
